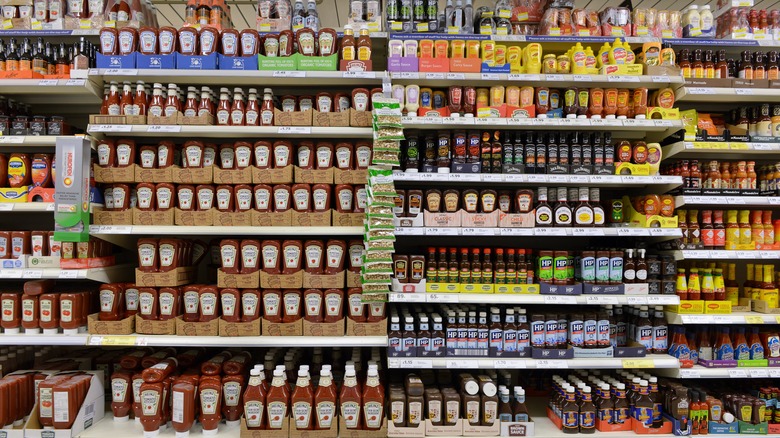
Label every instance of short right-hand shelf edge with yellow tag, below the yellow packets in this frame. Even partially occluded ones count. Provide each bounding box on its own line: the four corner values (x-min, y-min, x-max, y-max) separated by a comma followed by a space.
661, 141, 780, 160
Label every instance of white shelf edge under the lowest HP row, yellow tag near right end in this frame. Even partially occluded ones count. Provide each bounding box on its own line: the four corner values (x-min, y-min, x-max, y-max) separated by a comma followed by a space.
387, 354, 680, 370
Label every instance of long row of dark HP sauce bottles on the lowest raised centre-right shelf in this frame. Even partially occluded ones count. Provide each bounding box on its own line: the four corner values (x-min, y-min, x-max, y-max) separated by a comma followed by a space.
388, 305, 667, 356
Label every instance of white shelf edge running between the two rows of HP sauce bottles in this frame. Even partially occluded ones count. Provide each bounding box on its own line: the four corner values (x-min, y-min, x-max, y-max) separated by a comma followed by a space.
389, 292, 680, 306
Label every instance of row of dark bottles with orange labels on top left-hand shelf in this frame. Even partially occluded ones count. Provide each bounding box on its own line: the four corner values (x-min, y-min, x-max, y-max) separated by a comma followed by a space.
0, 37, 97, 76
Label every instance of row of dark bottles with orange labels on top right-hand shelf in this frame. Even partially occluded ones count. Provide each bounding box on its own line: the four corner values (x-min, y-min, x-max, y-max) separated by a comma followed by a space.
677, 49, 780, 80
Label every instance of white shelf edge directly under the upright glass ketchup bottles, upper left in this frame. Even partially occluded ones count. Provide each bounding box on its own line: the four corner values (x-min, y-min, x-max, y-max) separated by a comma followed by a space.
87, 125, 373, 139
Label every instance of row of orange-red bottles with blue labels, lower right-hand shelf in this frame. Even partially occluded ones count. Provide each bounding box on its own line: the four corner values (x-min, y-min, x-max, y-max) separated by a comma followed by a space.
669, 326, 780, 366
